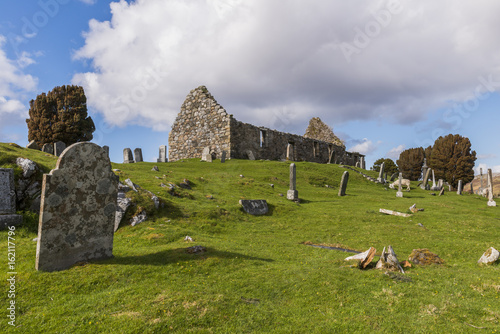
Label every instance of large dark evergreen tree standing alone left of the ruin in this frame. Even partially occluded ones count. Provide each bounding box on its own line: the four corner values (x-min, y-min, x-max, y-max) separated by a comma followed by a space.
26, 86, 95, 146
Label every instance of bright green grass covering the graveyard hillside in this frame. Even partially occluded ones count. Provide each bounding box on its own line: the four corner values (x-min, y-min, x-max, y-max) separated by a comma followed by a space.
0, 144, 500, 333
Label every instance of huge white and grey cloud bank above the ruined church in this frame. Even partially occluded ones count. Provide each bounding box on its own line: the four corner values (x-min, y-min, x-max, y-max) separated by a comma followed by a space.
73, 0, 500, 130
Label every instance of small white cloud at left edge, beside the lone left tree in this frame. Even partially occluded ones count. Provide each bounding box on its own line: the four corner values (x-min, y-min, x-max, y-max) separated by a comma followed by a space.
0, 35, 37, 141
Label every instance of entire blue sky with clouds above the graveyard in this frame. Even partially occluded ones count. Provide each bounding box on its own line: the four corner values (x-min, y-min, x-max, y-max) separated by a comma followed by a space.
0, 0, 500, 172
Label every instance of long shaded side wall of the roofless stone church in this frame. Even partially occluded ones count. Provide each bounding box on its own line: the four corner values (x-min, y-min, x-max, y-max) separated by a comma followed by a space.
230, 118, 345, 163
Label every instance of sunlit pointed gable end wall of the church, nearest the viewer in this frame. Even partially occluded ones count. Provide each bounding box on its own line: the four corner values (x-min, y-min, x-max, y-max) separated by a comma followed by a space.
168, 86, 230, 161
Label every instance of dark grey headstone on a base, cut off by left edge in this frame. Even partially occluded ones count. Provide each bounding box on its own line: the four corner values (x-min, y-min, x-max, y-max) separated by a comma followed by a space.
0, 168, 23, 230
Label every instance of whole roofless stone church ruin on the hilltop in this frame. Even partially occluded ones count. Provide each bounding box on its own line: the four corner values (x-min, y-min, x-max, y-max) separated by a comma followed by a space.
168, 86, 364, 167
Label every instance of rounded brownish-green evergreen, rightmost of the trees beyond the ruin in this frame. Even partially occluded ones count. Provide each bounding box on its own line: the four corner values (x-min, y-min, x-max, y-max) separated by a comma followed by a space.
427, 134, 476, 187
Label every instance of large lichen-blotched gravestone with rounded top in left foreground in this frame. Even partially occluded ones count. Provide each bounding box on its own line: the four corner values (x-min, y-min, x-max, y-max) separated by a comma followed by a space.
36, 142, 118, 271
